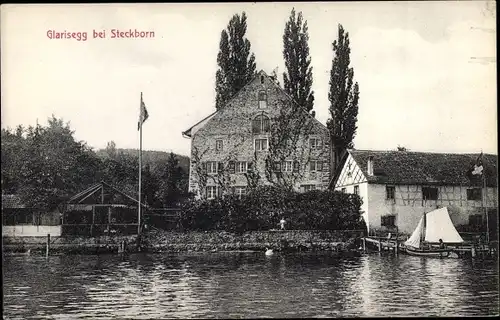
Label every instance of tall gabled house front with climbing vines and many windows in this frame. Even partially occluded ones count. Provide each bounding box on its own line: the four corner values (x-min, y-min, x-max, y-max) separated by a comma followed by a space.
183, 71, 331, 199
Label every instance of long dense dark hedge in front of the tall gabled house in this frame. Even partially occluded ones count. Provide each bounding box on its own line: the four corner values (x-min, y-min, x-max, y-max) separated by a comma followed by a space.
181, 186, 366, 233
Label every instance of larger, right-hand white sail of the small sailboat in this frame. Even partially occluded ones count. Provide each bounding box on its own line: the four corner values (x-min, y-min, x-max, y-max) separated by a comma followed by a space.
425, 207, 464, 243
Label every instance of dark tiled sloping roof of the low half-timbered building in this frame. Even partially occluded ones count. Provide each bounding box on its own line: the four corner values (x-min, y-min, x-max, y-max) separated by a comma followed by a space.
349, 150, 498, 187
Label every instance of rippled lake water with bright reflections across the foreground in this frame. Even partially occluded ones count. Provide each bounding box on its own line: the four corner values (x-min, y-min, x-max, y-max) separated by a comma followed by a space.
3, 252, 499, 319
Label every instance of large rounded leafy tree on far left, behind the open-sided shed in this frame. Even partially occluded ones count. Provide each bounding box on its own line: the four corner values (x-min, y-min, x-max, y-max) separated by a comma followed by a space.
16, 116, 99, 210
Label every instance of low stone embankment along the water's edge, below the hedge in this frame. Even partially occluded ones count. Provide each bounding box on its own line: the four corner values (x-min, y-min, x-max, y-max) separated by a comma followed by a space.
2, 230, 361, 255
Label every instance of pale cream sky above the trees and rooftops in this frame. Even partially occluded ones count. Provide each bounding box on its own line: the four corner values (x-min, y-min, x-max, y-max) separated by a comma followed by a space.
0, 1, 497, 155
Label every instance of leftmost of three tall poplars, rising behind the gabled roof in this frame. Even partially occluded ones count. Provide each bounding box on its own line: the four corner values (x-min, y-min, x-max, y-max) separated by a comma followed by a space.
215, 12, 256, 110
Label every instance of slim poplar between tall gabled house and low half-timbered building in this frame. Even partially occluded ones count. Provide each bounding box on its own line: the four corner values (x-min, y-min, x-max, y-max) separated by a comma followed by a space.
327, 24, 359, 170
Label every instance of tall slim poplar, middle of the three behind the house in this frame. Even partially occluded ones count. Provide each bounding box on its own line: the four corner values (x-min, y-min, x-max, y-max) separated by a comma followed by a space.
283, 9, 314, 111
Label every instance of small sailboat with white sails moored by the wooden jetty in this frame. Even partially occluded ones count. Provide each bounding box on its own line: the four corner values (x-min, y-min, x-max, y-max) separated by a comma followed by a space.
404, 207, 464, 257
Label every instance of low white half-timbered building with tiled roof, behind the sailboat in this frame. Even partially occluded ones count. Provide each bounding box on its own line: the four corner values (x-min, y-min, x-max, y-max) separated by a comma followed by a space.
332, 150, 498, 234
